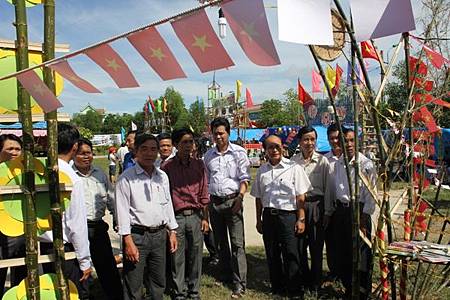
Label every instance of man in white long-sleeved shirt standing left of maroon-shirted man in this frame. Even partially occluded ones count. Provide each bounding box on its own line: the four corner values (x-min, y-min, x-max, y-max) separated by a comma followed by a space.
115, 134, 178, 300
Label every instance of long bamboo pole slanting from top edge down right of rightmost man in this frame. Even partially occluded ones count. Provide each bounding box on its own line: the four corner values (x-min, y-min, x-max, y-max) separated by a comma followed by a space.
333, 0, 396, 300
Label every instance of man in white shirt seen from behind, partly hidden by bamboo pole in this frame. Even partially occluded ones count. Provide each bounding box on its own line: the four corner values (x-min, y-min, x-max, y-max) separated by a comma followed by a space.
40, 124, 92, 299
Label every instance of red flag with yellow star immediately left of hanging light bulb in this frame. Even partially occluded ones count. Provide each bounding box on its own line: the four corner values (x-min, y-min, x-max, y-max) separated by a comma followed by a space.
172, 9, 234, 73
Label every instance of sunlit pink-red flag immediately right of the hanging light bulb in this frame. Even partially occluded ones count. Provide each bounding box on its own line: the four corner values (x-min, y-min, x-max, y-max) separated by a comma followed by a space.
222, 0, 280, 66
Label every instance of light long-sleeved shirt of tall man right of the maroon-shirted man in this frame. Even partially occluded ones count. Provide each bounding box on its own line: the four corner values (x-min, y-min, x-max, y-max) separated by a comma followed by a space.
203, 143, 250, 197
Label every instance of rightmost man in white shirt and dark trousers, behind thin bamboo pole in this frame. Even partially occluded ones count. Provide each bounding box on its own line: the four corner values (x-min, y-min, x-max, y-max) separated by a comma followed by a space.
333, 128, 377, 299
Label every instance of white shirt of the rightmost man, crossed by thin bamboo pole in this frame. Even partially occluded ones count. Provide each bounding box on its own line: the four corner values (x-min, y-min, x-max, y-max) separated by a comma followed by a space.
333, 153, 377, 215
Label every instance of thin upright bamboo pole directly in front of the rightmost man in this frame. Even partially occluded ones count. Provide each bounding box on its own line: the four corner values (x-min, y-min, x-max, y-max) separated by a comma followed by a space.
351, 42, 360, 300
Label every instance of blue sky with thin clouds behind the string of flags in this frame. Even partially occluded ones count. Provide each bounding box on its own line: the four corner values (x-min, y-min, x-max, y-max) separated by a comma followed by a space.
0, 0, 428, 114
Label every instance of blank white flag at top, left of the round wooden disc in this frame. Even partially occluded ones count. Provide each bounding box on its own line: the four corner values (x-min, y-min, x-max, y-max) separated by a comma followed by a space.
278, 0, 334, 45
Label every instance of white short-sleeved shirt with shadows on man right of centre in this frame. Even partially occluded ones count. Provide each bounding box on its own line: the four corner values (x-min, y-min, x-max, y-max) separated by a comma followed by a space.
250, 158, 312, 211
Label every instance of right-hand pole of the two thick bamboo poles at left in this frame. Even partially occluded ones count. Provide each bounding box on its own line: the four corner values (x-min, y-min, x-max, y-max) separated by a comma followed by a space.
43, 0, 69, 300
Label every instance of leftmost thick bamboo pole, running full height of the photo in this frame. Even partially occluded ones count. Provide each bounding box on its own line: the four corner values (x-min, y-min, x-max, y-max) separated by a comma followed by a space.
14, 0, 40, 300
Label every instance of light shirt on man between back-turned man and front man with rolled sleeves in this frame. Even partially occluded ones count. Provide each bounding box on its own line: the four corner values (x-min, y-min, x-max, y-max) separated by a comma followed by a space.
73, 165, 114, 221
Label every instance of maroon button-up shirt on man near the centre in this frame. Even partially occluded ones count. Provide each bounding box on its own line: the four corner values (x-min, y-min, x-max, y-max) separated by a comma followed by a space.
161, 156, 209, 212
